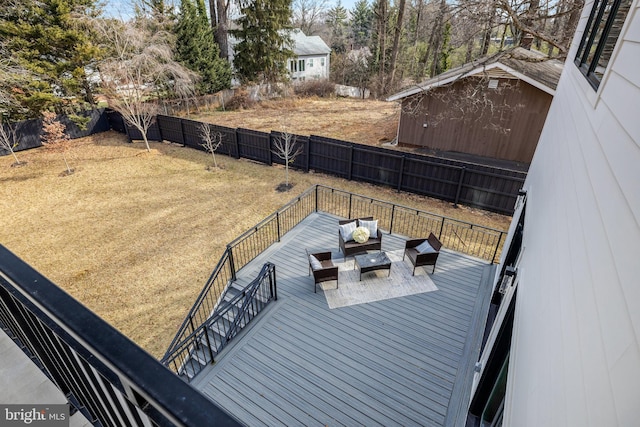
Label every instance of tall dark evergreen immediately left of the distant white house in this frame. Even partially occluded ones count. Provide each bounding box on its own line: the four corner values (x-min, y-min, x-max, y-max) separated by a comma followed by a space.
230, 0, 293, 83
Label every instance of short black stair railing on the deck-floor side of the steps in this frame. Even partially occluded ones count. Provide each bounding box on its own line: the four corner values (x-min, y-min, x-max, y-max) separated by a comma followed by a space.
161, 263, 278, 381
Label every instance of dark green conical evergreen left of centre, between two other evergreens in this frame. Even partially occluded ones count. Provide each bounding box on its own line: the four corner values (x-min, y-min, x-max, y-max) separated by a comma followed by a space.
175, 0, 231, 94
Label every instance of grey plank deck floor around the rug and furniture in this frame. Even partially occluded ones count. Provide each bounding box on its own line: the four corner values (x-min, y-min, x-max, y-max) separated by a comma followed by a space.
192, 214, 494, 426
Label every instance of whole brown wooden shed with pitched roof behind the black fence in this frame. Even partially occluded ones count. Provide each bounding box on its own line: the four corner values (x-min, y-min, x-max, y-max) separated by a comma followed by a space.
388, 47, 563, 163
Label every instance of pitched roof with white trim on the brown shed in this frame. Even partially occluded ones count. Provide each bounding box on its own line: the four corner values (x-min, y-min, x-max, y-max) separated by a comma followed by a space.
387, 47, 563, 101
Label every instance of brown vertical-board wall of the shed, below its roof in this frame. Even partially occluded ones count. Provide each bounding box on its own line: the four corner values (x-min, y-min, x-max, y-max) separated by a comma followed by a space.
398, 77, 553, 163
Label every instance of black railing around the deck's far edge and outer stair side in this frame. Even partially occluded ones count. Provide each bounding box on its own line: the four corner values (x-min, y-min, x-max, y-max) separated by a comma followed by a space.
163, 185, 506, 369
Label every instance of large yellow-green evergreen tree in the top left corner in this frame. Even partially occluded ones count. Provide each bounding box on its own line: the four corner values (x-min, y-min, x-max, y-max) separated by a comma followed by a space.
0, 0, 100, 119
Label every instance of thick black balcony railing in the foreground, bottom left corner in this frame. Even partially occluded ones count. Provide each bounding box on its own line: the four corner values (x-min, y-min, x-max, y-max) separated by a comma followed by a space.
0, 245, 240, 427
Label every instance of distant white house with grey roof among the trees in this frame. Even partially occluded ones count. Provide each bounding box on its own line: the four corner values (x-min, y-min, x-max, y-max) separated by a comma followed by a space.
288, 29, 331, 81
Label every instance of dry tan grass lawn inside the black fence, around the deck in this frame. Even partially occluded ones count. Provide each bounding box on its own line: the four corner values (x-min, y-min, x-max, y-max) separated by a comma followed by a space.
0, 132, 509, 357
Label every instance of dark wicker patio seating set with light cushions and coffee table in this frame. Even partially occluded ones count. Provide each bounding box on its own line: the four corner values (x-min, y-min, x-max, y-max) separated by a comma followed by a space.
307, 217, 442, 292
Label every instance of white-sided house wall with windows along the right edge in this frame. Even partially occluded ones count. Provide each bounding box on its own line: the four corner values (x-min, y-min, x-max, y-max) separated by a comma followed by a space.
467, 0, 640, 427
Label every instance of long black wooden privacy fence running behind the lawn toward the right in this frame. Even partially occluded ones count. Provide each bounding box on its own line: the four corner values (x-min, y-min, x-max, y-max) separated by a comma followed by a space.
110, 115, 526, 215
